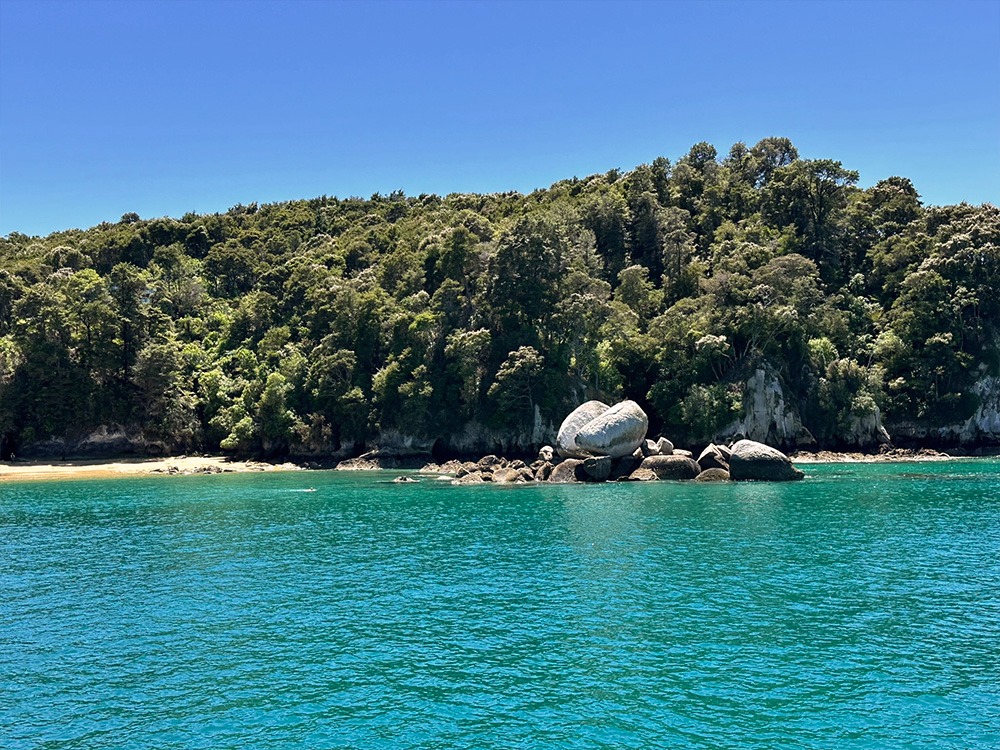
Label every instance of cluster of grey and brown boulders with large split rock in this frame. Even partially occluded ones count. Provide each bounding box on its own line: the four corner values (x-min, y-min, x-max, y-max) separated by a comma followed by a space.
448, 401, 804, 484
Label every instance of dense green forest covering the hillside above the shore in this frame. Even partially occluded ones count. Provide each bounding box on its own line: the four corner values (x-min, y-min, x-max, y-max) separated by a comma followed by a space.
0, 138, 1000, 462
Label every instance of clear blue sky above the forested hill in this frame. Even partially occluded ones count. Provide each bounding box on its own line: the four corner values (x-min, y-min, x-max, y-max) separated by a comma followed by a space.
0, 0, 1000, 235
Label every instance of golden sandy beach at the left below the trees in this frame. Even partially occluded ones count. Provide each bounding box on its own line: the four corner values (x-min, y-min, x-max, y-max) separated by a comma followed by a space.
0, 456, 302, 483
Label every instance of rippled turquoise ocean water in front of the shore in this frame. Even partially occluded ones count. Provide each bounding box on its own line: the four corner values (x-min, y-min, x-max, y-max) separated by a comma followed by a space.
0, 460, 1000, 750
